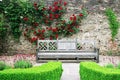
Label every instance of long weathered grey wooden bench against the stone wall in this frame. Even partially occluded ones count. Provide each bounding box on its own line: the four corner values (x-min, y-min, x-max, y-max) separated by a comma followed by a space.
36, 39, 99, 62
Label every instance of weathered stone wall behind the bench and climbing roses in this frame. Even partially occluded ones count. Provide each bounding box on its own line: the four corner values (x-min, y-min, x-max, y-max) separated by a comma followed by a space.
0, 0, 120, 54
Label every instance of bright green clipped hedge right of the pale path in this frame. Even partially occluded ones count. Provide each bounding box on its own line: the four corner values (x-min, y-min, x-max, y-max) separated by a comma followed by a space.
80, 62, 120, 80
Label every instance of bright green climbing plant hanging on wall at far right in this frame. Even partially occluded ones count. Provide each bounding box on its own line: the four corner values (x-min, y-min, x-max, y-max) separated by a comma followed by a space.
105, 9, 120, 40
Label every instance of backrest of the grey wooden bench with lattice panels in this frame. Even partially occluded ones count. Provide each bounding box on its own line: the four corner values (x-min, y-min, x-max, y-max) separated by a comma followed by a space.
38, 40, 96, 51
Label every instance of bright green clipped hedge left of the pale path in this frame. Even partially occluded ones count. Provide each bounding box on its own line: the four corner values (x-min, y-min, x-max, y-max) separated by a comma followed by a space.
0, 62, 63, 80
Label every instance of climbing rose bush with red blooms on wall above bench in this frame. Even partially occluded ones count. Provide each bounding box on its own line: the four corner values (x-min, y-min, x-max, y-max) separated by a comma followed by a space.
21, 0, 84, 43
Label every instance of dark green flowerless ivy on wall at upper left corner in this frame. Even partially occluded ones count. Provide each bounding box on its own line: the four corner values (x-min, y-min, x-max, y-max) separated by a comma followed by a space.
0, 0, 22, 39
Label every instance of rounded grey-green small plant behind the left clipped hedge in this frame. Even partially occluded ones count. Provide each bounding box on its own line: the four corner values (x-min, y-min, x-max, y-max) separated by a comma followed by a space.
14, 60, 32, 68
